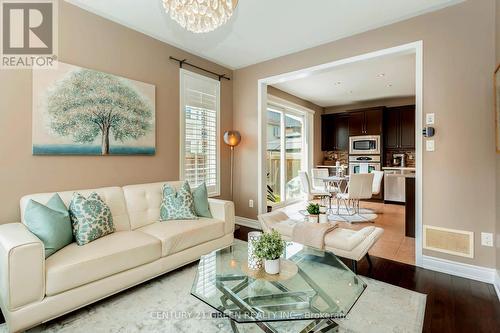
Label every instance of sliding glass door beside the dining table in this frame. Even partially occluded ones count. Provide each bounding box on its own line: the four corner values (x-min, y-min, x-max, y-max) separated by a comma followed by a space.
266, 105, 307, 207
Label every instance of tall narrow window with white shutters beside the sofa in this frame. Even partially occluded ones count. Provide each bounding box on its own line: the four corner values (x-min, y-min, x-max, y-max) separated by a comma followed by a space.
180, 69, 220, 196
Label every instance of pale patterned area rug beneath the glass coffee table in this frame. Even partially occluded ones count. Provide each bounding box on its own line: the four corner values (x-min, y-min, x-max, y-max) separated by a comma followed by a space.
0, 264, 426, 333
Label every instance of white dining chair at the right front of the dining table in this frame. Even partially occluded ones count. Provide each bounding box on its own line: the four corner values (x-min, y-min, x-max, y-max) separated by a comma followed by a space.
336, 173, 375, 215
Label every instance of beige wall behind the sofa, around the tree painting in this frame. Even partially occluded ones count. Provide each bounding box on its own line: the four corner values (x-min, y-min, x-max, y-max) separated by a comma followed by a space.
0, 1, 233, 223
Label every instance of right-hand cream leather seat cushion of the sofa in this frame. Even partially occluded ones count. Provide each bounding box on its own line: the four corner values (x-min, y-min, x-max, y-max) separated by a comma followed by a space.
137, 218, 224, 256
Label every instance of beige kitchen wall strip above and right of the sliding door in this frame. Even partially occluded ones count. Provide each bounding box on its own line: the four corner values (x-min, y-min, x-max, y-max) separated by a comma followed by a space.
267, 86, 324, 164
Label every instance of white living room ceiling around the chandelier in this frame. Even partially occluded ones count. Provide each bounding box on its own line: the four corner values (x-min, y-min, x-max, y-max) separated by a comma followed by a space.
66, 0, 463, 69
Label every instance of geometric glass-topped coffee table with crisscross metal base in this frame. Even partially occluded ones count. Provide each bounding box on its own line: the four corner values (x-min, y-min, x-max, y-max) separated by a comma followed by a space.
191, 241, 366, 333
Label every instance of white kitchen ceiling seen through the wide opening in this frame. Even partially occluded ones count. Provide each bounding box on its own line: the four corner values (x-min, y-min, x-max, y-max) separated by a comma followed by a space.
274, 53, 415, 107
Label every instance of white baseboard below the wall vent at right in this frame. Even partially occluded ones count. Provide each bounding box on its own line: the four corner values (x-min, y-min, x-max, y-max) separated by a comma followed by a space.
422, 256, 500, 284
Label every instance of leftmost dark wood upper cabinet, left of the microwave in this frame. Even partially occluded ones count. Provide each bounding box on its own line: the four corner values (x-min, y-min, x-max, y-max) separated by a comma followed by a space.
321, 114, 349, 151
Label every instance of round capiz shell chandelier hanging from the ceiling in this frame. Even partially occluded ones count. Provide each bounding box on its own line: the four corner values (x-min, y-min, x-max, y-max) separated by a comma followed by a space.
163, 0, 238, 33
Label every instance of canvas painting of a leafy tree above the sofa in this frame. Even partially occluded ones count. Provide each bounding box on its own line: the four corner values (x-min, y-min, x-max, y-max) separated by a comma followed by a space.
33, 63, 156, 155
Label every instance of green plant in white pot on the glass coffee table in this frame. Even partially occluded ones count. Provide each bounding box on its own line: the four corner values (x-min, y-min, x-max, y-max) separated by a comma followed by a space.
254, 230, 286, 274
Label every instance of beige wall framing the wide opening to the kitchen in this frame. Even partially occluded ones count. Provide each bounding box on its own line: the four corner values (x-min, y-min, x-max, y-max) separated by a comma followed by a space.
233, 0, 495, 267
